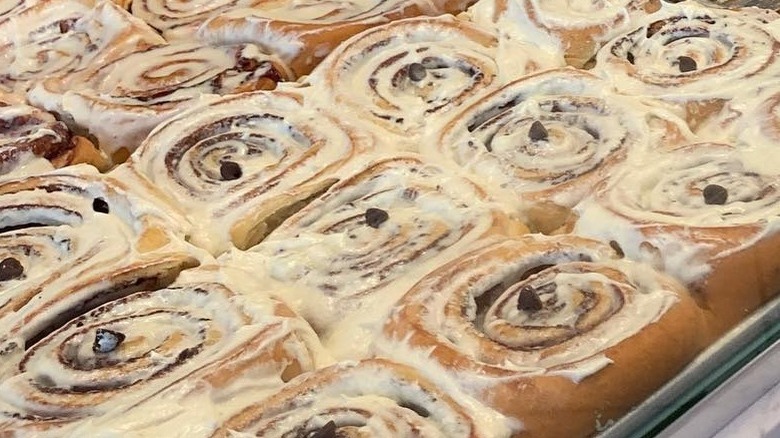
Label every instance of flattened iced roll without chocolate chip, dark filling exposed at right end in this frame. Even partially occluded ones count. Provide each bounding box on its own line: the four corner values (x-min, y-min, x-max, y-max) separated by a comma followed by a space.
29, 43, 291, 163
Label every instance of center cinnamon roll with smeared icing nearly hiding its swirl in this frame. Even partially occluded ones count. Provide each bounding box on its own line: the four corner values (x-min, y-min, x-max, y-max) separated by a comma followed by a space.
234, 156, 527, 357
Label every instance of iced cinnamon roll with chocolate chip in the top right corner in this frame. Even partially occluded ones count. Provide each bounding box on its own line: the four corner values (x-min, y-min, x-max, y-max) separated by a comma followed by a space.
595, 1, 780, 128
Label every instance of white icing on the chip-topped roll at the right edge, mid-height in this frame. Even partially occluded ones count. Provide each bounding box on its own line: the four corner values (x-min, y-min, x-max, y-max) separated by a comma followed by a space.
575, 144, 780, 283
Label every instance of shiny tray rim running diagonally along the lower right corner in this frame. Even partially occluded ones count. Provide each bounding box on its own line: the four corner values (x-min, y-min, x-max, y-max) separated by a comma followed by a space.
598, 296, 780, 438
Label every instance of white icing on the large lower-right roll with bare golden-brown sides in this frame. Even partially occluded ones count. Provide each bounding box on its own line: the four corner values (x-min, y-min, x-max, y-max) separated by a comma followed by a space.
377, 237, 679, 384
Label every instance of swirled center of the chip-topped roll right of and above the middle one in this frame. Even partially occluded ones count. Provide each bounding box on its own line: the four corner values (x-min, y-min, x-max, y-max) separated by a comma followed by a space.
460, 96, 630, 186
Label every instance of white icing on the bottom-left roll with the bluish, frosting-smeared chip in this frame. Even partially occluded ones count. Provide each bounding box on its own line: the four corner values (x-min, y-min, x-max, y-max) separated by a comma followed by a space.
0, 266, 329, 436
